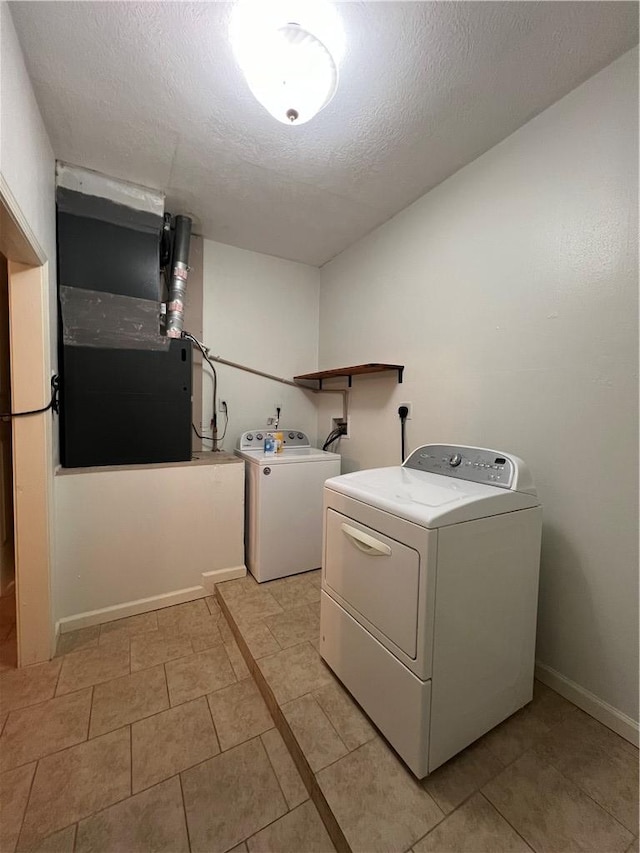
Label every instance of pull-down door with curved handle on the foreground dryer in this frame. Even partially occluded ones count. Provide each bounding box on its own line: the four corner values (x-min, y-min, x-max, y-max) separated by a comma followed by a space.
324, 509, 420, 660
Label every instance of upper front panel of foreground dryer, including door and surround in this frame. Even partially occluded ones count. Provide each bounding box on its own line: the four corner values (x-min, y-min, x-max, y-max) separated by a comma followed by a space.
323, 489, 437, 679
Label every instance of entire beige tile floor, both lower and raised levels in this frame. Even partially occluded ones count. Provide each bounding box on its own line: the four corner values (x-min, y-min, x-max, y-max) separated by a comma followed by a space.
0, 573, 638, 853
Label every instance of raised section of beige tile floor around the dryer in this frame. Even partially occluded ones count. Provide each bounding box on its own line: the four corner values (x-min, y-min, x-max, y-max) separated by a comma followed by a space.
217, 572, 638, 853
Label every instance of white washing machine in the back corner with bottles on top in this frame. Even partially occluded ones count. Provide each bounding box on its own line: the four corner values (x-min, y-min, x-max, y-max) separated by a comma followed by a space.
236, 429, 341, 582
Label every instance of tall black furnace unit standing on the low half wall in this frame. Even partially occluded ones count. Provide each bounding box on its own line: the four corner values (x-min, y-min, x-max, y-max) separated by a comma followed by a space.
56, 187, 191, 468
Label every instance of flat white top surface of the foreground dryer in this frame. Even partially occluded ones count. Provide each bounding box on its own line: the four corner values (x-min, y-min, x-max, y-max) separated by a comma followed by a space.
325, 467, 539, 527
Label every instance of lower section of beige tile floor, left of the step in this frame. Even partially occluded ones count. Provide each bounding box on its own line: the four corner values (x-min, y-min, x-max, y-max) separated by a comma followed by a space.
0, 598, 334, 853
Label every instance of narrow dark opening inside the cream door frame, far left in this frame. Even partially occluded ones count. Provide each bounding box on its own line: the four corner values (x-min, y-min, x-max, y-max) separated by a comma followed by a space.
0, 254, 18, 672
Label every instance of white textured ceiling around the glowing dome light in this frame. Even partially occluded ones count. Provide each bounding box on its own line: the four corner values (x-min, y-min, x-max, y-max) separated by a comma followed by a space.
10, 0, 638, 265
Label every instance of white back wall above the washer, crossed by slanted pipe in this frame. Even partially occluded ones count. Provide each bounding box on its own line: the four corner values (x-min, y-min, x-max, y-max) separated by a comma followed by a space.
203, 240, 320, 451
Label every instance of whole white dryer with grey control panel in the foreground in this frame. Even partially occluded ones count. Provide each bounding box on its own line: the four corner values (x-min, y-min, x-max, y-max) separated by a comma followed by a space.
320, 445, 542, 778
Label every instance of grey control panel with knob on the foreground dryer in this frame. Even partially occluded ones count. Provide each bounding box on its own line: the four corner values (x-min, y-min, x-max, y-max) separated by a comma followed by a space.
402, 444, 515, 489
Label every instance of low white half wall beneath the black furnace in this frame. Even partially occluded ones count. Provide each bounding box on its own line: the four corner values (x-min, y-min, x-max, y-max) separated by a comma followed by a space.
56, 454, 245, 629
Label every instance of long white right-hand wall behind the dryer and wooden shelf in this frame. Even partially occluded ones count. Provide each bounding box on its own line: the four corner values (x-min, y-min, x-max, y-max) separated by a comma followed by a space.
319, 50, 638, 720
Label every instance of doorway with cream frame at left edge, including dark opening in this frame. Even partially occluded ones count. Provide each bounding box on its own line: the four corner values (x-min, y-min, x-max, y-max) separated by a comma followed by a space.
0, 191, 55, 668
